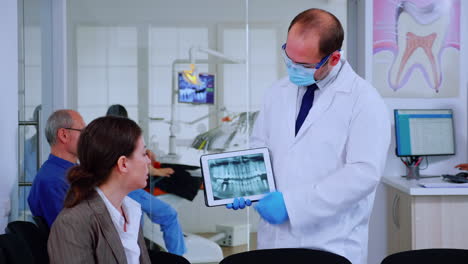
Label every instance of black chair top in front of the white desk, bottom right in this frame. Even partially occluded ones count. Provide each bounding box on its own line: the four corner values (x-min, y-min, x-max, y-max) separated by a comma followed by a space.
381, 248, 468, 264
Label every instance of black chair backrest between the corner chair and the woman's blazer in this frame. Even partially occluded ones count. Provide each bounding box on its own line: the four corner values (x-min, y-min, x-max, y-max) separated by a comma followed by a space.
5, 221, 49, 264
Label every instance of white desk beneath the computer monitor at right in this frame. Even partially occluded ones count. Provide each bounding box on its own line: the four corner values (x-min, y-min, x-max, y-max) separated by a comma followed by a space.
382, 176, 468, 254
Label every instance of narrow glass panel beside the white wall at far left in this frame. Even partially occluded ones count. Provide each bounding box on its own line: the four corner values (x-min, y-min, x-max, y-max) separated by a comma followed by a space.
15, 0, 44, 221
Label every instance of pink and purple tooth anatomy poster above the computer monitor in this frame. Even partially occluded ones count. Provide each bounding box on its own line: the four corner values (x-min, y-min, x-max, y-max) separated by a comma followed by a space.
372, 0, 460, 98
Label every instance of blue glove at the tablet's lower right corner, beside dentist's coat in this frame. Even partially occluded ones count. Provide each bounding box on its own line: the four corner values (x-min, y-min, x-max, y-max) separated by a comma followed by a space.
254, 192, 289, 225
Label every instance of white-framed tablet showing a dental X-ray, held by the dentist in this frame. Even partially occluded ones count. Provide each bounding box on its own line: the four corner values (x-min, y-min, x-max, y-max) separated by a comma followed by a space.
200, 148, 276, 206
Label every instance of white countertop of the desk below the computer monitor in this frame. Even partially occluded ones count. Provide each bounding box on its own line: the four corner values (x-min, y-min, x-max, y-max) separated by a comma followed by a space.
382, 176, 468, 195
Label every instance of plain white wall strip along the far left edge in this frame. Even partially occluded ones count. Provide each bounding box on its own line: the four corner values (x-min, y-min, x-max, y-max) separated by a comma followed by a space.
0, 0, 18, 234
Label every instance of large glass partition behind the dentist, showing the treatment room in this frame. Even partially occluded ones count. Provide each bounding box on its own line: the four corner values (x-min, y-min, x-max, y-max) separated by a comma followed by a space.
67, 0, 347, 263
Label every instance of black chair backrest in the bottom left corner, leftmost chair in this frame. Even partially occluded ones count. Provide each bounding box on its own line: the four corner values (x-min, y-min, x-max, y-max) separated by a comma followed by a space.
0, 234, 34, 264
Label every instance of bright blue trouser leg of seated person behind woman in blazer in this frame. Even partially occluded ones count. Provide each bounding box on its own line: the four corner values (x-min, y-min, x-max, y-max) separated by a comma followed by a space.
128, 189, 187, 256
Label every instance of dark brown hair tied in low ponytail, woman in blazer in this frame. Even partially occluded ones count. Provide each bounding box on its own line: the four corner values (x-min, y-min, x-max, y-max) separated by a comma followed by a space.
65, 116, 142, 208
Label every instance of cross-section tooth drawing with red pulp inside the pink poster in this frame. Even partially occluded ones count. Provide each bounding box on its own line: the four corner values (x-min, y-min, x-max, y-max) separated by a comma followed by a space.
390, 1, 449, 92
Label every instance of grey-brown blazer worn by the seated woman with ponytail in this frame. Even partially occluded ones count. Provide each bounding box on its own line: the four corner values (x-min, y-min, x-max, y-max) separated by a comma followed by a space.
47, 191, 151, 264
